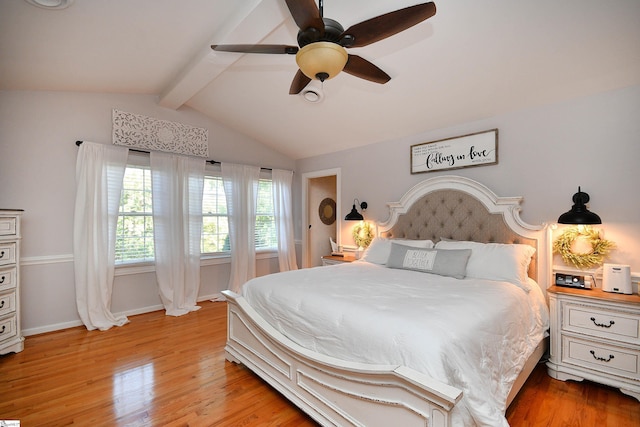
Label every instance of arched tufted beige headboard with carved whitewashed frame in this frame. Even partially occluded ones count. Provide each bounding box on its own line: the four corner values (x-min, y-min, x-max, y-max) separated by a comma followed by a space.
378, 176, 550, 289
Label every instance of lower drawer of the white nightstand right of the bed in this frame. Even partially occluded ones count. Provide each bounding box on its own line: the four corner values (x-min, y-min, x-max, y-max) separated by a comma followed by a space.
562, 337, 640, 380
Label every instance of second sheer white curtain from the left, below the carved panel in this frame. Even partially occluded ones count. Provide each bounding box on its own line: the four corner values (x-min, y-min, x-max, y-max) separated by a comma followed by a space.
151, 152, 205, 316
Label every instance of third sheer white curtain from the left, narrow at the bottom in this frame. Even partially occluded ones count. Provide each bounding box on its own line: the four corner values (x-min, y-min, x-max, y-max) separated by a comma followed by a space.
221, 163, 260, 293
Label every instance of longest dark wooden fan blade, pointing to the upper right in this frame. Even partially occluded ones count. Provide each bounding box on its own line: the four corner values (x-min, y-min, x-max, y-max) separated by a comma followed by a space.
341, 2, 436, 47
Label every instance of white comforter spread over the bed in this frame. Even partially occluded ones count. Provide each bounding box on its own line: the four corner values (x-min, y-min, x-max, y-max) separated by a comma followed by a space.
242, 261, 548, 427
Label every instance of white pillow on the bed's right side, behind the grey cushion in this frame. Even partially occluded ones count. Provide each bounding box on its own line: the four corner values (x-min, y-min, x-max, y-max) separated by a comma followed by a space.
435, 240, 536, 292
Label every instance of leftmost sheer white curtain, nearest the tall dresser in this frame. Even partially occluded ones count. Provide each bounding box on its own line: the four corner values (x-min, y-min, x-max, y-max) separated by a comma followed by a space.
73, 142, 129, 331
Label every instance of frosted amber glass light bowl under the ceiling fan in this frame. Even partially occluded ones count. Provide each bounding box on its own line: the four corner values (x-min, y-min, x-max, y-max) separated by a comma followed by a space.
296, 42, 349, 81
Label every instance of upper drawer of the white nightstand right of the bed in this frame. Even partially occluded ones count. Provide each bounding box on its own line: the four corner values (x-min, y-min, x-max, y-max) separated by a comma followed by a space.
562, 303, 640, 344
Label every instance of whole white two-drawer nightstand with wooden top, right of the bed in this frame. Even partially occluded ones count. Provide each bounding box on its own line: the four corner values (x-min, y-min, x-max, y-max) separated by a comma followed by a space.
547, 286, 640, 401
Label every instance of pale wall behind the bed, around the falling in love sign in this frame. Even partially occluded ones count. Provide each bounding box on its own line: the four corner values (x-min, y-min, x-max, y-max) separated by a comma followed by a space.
296, 86, 640, 272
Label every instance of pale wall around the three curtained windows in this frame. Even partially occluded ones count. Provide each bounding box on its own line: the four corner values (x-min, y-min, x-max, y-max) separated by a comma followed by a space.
0, 91, 294, 333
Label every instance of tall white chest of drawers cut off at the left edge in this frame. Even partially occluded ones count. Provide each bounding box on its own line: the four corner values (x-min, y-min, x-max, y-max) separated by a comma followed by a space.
0, 209, 24, 354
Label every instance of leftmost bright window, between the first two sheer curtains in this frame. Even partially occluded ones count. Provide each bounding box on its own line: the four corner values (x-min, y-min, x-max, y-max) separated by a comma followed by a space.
116, 166, 154, 264
